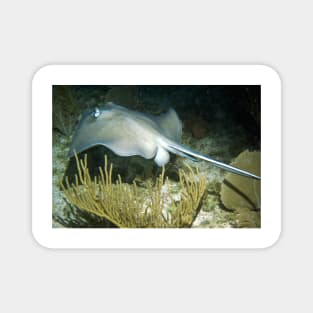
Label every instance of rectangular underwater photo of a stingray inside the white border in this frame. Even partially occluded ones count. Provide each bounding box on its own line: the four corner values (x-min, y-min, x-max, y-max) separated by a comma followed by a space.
52, 85, 261, 228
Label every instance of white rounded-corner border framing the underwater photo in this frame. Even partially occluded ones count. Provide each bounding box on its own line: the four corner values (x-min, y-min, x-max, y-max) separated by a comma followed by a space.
32, 65, 281, 248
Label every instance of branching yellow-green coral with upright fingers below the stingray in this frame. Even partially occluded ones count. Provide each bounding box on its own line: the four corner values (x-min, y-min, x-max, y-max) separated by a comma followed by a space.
61, 154, 206, 228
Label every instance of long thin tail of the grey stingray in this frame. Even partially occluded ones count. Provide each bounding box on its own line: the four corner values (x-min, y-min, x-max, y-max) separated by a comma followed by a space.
166, 141, 261, 180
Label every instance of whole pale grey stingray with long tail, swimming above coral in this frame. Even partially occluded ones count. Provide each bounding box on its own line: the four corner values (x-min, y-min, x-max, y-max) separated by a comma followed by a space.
69, 102, 261, 179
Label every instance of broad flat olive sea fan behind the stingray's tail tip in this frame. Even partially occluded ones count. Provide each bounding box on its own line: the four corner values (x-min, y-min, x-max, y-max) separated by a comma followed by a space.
221, 150, 261, 227
